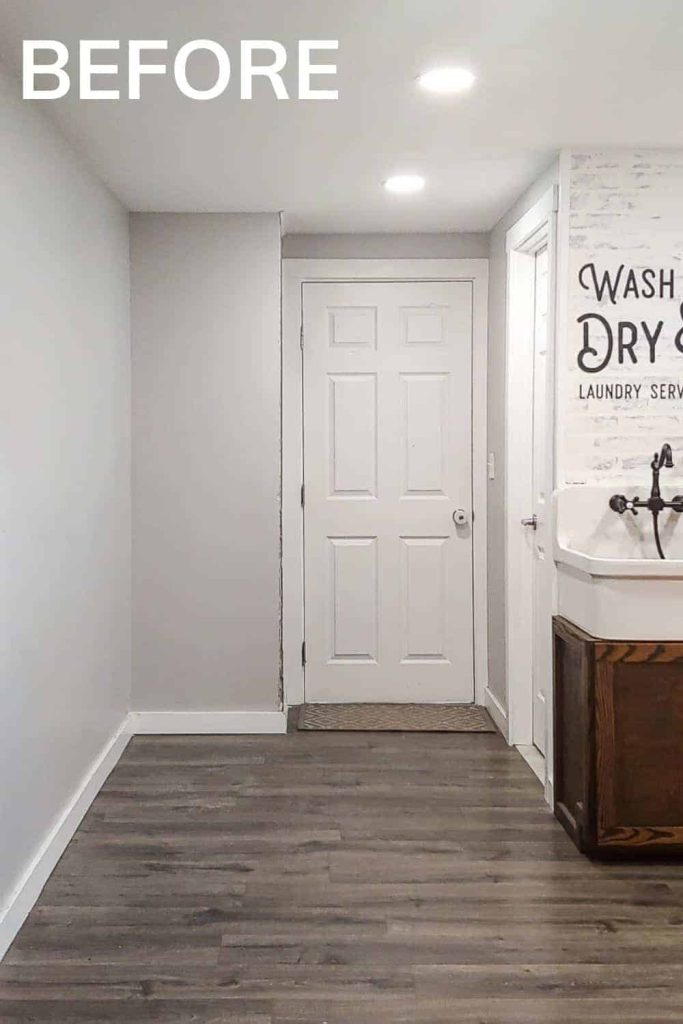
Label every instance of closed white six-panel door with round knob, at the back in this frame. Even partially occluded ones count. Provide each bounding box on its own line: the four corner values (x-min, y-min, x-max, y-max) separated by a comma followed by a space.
302, 282, 474, 702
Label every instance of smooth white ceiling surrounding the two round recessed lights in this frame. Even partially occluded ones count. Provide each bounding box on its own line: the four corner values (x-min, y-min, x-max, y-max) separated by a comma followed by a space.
0, 0, 683, 231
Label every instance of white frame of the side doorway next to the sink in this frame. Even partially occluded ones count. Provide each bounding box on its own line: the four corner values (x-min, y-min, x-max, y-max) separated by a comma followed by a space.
505, 185, 558, 782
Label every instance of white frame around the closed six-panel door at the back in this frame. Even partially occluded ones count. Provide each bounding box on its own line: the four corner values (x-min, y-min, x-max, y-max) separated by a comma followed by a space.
282, 259, 488, 707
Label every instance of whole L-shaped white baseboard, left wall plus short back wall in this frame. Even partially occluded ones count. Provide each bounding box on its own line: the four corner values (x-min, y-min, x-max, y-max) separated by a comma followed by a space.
0, 711, 287, 961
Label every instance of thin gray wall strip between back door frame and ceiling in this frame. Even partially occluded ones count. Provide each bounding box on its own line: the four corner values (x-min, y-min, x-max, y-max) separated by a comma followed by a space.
283, 232, 488, 259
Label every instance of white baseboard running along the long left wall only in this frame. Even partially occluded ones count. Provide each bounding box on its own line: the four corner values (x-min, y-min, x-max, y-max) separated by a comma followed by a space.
0, 716, 130, 961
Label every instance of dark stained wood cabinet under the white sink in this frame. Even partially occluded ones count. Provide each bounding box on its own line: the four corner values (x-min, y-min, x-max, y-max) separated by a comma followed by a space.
554, 616, 683, 856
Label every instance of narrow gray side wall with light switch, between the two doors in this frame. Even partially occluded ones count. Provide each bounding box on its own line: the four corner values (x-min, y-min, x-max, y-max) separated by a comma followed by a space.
487, 162, 559, 708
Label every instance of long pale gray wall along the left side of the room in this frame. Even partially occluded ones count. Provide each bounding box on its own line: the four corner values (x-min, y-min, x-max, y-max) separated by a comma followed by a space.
0, 73, 130, 921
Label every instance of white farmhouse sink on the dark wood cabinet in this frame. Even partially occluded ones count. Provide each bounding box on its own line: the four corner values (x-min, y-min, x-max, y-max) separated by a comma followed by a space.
553, 485, 683, 640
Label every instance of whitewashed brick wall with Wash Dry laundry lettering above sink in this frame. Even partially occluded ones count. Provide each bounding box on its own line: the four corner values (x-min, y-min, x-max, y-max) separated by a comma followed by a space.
558, 150, 683, 489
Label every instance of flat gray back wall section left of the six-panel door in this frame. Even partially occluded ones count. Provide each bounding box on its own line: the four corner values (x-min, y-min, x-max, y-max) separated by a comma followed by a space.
131, 214, 281, 711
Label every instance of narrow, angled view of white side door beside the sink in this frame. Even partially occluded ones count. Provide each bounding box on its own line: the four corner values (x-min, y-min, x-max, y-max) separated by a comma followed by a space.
531, 245, 552, 757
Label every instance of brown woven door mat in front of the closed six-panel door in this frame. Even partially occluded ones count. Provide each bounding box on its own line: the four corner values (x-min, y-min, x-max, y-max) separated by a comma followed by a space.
297, 703, 496, 732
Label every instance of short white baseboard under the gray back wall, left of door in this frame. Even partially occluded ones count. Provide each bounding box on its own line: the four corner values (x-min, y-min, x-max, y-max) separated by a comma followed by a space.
130, 711, 287, 736
